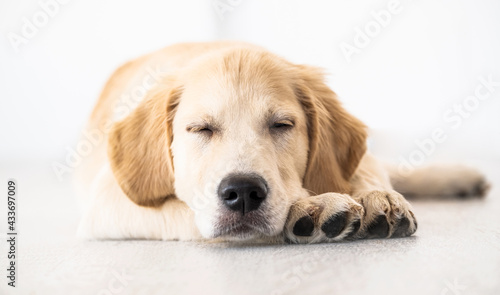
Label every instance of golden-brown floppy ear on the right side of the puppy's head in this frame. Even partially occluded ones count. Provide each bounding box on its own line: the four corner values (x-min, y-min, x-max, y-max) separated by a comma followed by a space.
296, 66, 366, 198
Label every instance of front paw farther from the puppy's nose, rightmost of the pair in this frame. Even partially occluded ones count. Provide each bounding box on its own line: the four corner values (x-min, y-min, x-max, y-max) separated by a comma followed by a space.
354, 191, 417, 238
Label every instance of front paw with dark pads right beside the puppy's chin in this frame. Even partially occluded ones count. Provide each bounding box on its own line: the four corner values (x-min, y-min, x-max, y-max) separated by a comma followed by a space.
284, 193, 364, 243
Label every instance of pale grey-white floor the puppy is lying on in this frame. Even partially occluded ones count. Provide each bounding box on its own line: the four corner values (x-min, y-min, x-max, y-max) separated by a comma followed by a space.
0, 162, 500, 295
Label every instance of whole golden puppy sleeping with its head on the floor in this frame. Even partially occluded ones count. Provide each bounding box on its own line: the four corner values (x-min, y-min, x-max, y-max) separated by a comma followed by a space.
78, 42, 486, 243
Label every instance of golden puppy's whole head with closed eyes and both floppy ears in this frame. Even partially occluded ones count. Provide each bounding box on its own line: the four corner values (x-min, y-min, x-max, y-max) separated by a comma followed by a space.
109, 49, 366, 239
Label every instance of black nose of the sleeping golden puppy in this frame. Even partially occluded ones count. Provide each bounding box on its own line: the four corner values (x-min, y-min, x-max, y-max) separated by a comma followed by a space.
218, 174, 267, 214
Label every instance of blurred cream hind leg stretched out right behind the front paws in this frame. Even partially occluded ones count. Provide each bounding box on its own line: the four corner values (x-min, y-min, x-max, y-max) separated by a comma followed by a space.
387, 164, 490, 199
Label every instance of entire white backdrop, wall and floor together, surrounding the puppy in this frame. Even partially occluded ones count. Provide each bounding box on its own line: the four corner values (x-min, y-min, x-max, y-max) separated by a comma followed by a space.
0, 0, 500, 295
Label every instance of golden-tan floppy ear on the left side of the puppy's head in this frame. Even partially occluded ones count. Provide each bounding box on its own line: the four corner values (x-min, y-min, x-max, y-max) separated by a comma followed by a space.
108, 80, 181, 207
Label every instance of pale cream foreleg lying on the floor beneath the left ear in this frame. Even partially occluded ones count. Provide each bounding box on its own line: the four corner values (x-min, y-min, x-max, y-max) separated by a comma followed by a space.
78, 167, 201, 240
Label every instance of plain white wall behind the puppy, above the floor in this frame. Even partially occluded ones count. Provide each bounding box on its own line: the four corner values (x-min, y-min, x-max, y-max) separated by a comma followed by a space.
0, 0, 500, 169
